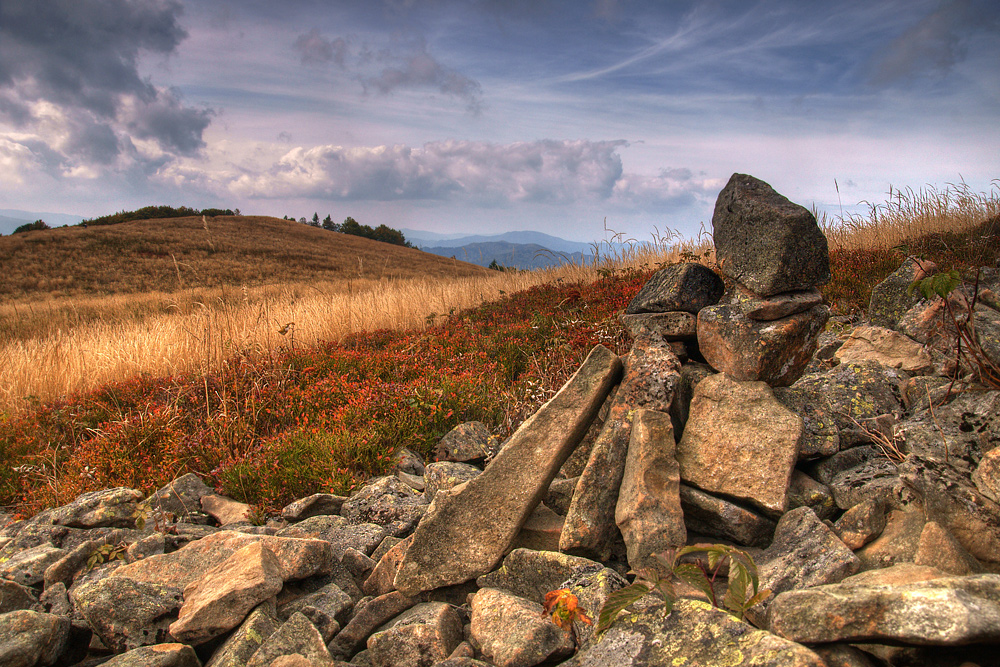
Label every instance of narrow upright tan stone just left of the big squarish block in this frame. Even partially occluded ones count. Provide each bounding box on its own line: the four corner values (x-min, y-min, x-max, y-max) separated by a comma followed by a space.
615, 408, 687, 569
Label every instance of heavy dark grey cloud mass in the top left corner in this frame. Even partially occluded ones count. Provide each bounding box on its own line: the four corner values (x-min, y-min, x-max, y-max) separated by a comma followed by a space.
0, 0, 211, 180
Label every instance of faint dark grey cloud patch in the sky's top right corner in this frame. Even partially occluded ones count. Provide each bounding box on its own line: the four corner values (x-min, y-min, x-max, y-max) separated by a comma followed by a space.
869, 0, 977, 85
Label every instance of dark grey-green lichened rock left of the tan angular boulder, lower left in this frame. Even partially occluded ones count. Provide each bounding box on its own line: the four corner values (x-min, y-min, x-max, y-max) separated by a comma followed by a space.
70, 576, 184, 653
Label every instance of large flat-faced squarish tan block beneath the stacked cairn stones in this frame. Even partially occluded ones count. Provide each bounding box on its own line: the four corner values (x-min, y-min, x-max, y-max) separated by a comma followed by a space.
676, 374, 802, 515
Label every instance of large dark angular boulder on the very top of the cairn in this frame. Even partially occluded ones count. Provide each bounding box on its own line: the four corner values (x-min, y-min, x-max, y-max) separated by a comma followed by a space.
712, 174, 830, 296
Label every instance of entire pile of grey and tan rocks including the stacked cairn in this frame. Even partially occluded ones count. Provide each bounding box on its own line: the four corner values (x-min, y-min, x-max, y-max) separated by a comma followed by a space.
0, 175, 1000, 667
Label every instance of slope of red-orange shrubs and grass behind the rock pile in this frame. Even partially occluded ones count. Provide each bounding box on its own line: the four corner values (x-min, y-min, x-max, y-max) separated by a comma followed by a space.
0, 180, 1000, 516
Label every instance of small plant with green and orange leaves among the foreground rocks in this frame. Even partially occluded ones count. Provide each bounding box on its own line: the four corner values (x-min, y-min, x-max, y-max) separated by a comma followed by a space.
597, 544, 771, 633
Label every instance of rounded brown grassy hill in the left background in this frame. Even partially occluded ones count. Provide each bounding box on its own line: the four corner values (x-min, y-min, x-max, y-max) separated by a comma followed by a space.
0, 216, 485, 298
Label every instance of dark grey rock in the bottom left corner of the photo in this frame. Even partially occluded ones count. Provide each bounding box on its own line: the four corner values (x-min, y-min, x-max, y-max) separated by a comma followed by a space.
0, 610, 69, 667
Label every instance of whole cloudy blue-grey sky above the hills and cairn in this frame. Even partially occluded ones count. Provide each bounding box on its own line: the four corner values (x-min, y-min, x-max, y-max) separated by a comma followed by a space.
0, 0, 1000, 242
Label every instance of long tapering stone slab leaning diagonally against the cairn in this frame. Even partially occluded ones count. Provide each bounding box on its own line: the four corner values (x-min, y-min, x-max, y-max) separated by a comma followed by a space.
394, 345, 622, 595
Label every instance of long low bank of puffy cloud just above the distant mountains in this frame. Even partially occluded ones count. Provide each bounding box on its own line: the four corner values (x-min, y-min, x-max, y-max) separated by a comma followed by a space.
228, 140, 721, 214
